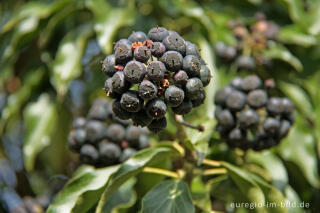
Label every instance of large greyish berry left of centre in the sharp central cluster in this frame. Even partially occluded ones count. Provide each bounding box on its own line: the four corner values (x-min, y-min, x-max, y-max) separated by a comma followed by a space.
124, 61, 146, 84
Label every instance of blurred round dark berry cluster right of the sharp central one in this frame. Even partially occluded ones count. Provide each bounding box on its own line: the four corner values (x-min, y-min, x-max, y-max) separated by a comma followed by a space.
214, 75, 294, 151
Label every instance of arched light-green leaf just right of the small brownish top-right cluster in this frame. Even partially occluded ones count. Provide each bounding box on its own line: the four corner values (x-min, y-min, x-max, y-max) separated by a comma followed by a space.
263, 43, 303, 71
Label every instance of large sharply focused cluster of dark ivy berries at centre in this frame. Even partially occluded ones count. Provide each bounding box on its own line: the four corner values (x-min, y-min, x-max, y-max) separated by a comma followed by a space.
102, 27, 211, 132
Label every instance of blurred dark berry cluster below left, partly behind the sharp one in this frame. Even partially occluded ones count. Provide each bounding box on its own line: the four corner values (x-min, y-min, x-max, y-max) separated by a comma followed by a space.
68, 98, 149, 167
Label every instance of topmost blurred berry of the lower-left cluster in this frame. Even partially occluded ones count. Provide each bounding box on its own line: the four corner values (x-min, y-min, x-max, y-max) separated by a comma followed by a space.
87, 98, 110, 121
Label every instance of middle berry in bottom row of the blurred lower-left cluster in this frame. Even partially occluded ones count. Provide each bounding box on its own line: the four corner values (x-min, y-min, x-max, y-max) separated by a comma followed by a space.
99, 140, 121, 165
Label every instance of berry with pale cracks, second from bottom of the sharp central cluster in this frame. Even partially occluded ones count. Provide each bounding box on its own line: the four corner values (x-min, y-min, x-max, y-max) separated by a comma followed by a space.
146, 98, 167, 119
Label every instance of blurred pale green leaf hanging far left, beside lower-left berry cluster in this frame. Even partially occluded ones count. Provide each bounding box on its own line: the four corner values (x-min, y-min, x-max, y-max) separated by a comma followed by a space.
23, 94, 57, 171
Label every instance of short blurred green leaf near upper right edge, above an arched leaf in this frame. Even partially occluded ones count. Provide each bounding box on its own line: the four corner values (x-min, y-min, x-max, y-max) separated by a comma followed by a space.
278, 25, 317, 47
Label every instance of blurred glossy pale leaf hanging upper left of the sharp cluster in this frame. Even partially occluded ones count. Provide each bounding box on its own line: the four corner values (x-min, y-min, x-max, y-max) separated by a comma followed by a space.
52, 25, 93, 96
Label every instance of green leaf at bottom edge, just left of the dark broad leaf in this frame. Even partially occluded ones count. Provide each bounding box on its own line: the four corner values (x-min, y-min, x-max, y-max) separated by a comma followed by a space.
104, 178, 137, 213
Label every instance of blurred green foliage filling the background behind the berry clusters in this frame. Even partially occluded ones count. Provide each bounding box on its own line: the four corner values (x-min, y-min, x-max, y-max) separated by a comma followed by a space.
0, 0, 320, 212
